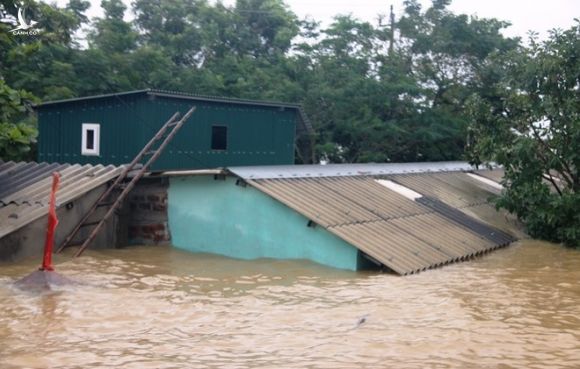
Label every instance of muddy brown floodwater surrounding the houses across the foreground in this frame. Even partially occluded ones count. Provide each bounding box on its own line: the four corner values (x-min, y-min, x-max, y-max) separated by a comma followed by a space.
0, 241, 580, 369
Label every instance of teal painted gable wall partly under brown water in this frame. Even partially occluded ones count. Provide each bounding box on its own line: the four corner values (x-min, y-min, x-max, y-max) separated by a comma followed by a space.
168, 176, 359, 270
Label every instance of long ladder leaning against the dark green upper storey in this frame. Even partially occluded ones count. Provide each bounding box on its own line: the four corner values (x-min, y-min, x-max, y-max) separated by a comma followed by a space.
57, 107, 195, 257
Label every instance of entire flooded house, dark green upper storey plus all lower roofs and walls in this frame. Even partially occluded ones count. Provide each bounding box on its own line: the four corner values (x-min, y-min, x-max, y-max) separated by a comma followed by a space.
0, 90, 522, 275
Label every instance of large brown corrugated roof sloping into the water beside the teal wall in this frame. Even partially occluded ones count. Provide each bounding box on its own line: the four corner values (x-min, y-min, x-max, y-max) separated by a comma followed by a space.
242, 168, 514, 275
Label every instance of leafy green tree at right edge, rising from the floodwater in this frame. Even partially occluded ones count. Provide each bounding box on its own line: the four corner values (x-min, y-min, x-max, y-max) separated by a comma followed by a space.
469, 23, 580, 246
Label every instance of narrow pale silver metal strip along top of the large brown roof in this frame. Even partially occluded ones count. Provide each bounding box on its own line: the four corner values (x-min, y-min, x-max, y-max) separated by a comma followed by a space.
228, 161, 473, 179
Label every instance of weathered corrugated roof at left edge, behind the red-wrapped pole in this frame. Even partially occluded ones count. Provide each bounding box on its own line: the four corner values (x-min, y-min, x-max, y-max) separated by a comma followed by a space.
0, 162, 123, 238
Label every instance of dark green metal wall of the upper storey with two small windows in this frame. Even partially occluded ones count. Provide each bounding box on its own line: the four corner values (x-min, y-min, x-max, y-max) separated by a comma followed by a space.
38, 94, 298, 170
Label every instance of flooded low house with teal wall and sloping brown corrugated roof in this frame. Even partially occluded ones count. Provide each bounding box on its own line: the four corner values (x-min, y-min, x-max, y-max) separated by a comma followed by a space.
168, 162, 521, 275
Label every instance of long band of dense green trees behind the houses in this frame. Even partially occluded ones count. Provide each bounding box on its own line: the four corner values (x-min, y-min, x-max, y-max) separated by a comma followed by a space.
0, 0, 517, 162
